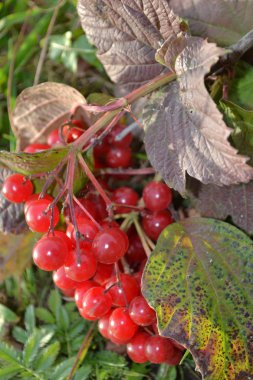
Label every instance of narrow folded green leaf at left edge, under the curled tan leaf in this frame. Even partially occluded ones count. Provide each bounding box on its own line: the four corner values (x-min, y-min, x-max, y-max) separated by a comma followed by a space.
0, 147, 69, 175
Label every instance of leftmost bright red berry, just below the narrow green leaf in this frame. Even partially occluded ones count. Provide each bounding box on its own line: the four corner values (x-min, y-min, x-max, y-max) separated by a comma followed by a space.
2, 174, 33, 203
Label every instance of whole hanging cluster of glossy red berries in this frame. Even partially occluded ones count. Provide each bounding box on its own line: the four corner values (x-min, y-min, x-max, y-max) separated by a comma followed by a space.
2, 121, 184, 365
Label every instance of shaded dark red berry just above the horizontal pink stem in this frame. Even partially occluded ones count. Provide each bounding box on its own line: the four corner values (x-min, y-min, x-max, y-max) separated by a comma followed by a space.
105, 147, 132, 168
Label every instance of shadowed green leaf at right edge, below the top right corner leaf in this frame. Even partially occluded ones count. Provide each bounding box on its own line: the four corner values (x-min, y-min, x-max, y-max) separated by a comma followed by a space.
228, 62, 253, 110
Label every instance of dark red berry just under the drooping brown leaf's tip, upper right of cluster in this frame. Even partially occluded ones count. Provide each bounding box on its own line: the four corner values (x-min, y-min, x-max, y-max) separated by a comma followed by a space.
142, 182, 172, 211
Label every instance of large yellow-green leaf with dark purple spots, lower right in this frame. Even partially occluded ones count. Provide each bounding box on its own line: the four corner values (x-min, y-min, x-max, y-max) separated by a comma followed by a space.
142, 218, 253, 380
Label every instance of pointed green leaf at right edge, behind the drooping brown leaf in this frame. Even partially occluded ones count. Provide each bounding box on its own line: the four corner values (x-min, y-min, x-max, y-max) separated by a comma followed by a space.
220, 100, 253, 165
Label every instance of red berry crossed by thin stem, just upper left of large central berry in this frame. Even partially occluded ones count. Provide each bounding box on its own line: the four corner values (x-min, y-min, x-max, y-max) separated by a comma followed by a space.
66, 217, 98, 248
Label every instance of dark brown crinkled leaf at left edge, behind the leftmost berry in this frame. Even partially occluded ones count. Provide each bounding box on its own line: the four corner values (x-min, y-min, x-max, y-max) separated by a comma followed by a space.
0, 168, 27, 235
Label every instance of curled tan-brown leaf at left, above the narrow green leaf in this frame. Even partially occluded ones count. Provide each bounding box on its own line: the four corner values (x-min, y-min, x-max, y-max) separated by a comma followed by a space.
13, 82, 86, 150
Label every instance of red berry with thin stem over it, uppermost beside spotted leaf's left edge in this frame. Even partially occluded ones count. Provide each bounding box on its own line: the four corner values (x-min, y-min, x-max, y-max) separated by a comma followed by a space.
106, 273, 140, 306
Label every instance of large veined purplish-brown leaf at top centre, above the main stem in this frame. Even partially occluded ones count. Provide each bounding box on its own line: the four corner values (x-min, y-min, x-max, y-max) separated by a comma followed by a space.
78, 0, 184, 92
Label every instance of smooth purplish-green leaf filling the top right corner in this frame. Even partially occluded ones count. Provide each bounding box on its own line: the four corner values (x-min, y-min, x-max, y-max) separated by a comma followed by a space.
170, 0, 253, 46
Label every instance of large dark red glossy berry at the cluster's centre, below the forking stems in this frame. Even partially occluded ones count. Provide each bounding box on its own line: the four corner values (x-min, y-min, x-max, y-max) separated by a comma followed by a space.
92, 227, 128, 264
